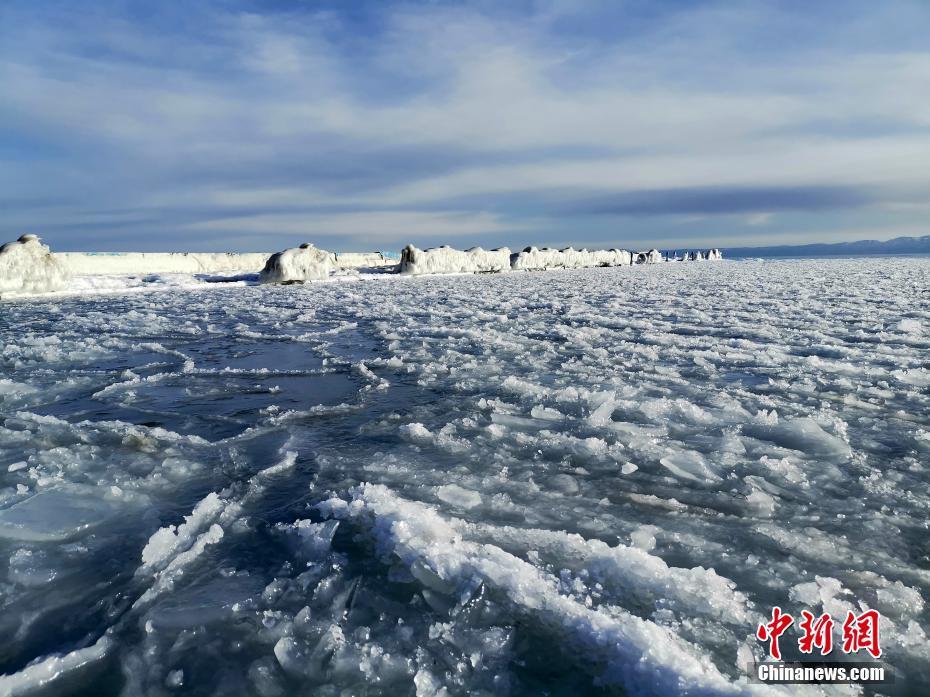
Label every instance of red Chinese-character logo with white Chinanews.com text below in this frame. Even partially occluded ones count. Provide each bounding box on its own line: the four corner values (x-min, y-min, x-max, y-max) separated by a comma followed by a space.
749, 607, 894, 685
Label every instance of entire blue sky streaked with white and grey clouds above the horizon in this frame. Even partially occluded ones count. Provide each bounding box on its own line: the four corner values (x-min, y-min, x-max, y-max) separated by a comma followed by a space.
0, 0, 930, 251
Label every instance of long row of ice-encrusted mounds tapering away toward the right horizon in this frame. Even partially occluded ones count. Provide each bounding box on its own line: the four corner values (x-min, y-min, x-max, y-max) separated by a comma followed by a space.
399, 244, 723, 275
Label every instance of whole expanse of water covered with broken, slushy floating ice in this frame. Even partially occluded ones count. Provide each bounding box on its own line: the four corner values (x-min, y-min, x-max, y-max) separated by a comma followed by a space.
0, 259, 930, 695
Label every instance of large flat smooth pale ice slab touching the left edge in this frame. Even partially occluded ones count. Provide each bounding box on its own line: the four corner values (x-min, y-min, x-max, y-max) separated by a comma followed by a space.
0, 489, 115, 542
